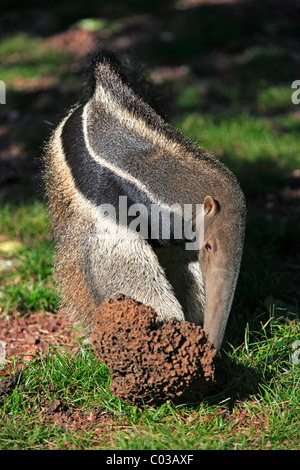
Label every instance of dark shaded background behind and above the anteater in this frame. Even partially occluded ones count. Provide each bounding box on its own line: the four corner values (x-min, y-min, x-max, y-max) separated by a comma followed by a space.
0, 0, 300, 344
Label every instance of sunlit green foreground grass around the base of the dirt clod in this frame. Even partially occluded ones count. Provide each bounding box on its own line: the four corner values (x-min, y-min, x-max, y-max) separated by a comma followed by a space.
0, 317, 300, 450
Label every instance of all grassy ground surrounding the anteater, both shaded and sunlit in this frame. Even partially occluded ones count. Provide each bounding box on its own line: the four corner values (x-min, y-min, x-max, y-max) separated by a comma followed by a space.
0, 2, 300, 450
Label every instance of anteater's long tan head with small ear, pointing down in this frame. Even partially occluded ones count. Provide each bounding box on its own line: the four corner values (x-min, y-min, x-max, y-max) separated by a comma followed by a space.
200, 187, 246, 349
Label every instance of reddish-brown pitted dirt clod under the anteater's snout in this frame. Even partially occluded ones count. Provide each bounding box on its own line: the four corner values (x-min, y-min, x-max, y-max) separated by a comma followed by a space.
92, 294, 216, 405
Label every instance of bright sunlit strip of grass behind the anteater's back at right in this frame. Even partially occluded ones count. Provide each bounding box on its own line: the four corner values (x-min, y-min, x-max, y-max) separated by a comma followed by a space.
176, 113, 300, 168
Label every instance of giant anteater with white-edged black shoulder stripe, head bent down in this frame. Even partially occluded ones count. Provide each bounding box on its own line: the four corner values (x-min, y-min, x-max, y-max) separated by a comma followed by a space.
45, 51, 246, 349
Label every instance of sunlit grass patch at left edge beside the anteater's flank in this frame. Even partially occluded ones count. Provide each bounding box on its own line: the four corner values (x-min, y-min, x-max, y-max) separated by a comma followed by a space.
0, 201, 58, 313
